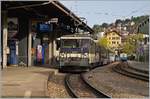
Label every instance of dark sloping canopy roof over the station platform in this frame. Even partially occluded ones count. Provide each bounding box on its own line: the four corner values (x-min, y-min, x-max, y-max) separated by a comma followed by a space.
1, 0, 94, 33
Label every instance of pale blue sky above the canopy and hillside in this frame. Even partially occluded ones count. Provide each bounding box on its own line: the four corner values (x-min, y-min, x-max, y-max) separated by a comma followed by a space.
60, 0, 150, 27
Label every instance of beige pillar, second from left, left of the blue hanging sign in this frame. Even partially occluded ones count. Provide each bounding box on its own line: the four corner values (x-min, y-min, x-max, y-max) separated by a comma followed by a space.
28, 20, 32, 66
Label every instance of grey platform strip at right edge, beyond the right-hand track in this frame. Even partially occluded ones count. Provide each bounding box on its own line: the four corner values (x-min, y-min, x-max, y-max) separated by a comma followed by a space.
128, 61, 149, 73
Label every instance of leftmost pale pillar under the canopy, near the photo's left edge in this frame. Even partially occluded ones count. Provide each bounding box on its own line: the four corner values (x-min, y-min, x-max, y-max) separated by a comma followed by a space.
2, 11, 8, 68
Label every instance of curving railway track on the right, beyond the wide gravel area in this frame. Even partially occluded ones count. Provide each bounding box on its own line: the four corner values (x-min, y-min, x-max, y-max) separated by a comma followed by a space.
113, 64, 149, 81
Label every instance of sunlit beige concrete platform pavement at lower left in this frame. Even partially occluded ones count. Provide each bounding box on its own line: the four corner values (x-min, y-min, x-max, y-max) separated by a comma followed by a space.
1, 67, 56, 98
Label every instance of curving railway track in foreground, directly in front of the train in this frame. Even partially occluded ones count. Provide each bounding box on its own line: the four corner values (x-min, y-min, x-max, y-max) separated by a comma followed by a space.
65, 74, 109, 98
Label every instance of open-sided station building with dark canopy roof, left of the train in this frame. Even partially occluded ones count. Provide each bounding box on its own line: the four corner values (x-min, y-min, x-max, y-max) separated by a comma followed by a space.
1, 0, 93, 68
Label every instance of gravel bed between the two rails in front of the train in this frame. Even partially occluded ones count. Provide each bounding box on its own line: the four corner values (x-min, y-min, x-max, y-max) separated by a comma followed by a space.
69, 74, 96, 98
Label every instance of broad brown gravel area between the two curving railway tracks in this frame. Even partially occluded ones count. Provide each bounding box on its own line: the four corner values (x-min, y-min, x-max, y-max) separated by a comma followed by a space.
84, 63, 149, 98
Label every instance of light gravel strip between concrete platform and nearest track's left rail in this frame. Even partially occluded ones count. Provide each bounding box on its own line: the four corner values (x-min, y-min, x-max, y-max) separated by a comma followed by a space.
48, 73, 71, 98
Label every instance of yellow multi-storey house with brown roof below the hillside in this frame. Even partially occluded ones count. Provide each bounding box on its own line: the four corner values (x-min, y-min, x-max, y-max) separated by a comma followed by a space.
105, 30, 121, 51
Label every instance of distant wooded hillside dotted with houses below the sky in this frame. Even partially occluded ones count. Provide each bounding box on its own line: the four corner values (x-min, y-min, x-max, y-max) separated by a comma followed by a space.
93, 15, 149, 33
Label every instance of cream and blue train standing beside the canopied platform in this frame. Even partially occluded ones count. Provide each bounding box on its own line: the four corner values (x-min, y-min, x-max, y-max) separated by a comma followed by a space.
59, 33, 109, 71
